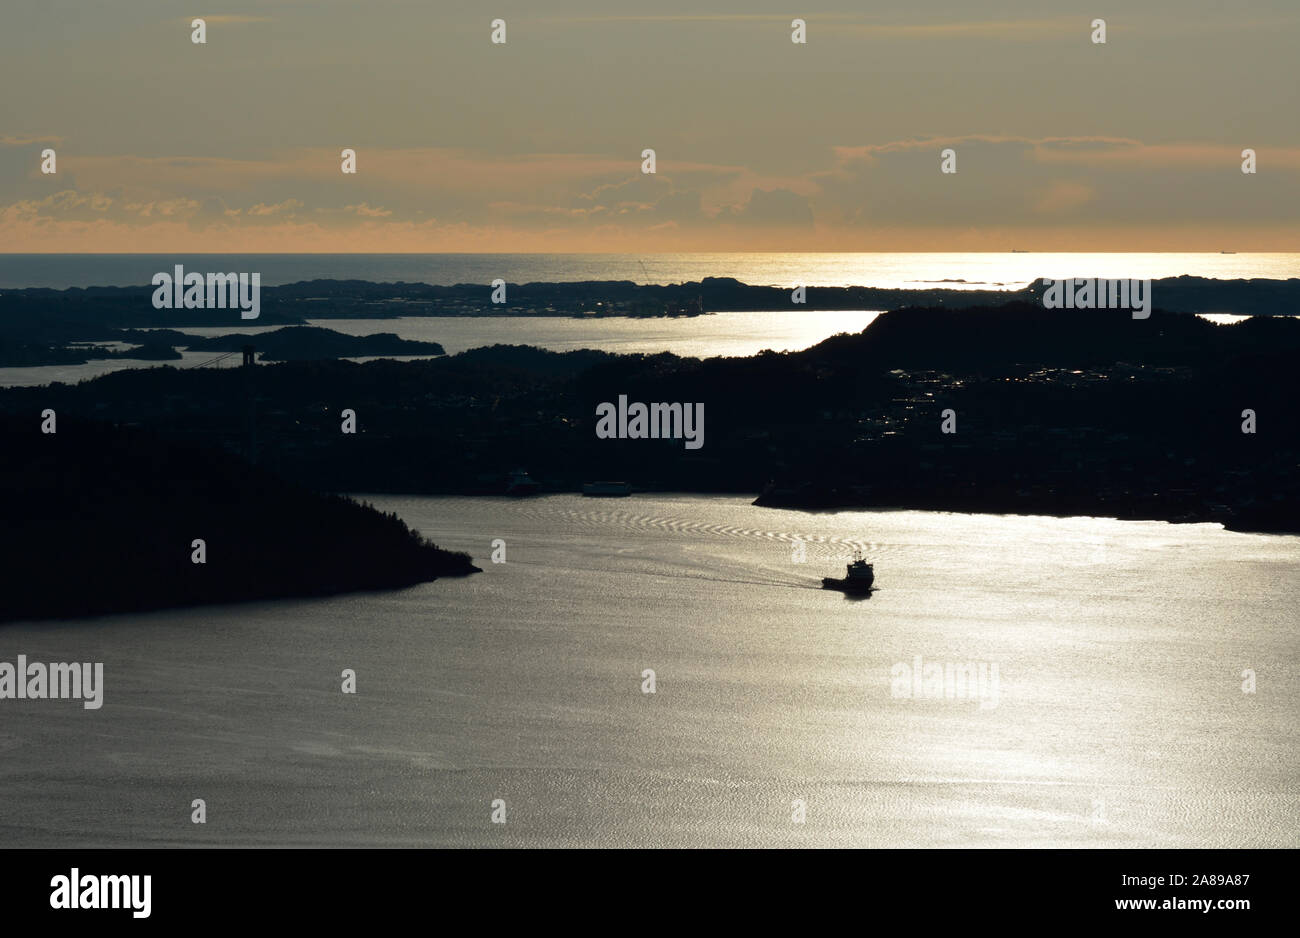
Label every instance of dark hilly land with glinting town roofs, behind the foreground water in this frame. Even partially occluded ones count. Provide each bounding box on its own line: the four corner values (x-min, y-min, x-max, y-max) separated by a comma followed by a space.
0, 300, 1300, 531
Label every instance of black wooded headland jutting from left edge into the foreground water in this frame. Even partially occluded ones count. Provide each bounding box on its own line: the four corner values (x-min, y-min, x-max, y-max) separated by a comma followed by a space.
0, 414, 477, 621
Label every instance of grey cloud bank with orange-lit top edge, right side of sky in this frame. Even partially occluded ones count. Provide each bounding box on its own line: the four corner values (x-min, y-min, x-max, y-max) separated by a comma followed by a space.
811, 135, 1300, 230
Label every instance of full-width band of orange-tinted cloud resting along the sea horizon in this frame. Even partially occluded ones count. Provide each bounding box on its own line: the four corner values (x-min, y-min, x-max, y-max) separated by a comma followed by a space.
0, 134, 1300, 252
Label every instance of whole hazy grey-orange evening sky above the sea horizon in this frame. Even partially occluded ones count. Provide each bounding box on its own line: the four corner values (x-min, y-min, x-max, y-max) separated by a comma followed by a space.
0, 0, 1300, 253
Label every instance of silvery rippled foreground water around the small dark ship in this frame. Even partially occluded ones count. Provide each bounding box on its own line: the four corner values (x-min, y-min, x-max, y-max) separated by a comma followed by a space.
0, 495, 1300, 847
